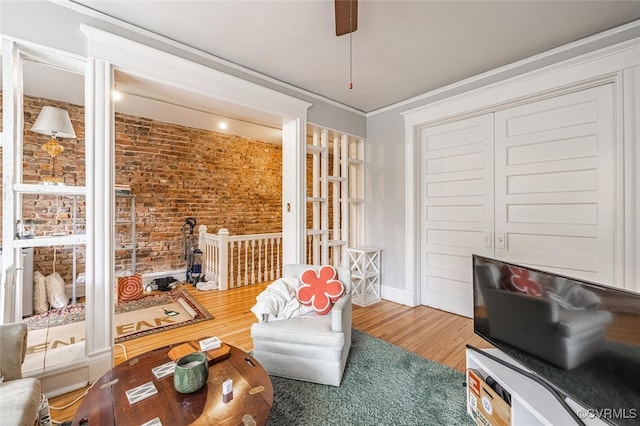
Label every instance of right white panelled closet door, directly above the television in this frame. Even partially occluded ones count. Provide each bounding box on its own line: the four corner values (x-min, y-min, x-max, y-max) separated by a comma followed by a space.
495, 84, 616, 284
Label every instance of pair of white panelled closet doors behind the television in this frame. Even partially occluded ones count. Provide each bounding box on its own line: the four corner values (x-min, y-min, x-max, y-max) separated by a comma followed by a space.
420, 84, 616, 316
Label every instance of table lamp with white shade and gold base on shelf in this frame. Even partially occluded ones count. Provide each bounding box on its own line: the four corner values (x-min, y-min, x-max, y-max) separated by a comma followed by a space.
31, 106, 76, 185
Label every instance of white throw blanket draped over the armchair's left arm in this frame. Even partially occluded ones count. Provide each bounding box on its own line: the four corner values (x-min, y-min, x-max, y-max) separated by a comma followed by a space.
251, 277, 313, 321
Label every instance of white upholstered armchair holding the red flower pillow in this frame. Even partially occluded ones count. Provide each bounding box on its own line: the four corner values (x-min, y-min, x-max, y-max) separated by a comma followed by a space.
251, 265, 351, 386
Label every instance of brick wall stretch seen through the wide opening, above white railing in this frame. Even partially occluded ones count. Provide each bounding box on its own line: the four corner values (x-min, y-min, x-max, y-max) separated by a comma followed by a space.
116, 114, 282, 272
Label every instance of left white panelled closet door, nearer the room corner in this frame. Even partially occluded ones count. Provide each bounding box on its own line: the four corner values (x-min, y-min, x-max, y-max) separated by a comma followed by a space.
420, 114, 494, 316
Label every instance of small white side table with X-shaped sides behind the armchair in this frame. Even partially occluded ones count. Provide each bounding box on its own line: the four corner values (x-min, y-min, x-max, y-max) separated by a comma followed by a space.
347, 247, 382, 306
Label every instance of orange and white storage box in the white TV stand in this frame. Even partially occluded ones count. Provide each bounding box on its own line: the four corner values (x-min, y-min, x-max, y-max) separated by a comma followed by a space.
467, 368, 511, 426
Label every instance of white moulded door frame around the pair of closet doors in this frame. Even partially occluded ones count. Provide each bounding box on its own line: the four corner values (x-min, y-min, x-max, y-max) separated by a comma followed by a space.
403, 38, 640, 305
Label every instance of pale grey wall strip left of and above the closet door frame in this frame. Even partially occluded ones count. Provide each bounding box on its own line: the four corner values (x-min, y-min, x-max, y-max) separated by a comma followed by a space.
365, 22, 640, 305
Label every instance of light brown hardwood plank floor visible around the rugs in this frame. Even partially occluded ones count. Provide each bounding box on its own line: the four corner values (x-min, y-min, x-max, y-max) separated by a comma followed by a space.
49, 283, 491, 421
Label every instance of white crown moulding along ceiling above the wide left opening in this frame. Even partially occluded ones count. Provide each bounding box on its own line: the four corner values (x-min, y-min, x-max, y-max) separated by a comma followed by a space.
51, 0, 367, 117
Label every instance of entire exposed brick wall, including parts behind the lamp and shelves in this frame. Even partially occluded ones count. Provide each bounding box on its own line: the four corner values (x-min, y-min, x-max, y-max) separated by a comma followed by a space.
0, 98, 282, 282
